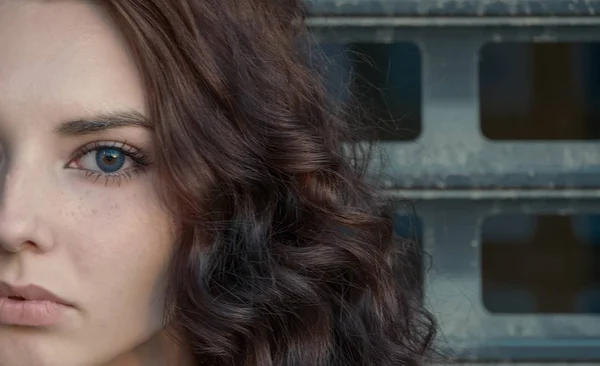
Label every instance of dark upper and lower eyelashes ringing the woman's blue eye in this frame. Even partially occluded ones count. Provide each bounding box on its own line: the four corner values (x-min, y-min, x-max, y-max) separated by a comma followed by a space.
66, 141, 151, 186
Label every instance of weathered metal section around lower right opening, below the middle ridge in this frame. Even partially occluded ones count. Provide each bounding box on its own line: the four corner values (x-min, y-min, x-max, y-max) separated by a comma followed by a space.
406, 197, 600, 362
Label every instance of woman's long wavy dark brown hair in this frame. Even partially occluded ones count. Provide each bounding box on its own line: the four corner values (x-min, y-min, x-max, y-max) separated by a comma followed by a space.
101, 0, 434, 366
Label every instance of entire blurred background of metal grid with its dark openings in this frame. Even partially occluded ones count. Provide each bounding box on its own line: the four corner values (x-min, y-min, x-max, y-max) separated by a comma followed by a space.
308, 0, 600, 363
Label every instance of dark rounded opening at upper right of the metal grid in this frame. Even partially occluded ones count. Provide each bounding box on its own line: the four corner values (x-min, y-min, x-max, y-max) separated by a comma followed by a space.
479, 43, 600, 140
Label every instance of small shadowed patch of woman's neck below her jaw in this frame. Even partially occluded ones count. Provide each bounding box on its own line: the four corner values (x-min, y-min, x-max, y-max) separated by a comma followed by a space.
106, 331, 192, 366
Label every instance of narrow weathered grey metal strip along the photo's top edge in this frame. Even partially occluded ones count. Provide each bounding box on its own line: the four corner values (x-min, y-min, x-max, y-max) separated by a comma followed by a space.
307, 0, 600, 17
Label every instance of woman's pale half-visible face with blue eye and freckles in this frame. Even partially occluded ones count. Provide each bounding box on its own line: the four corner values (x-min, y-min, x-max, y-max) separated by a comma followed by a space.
0, 0, 173, 366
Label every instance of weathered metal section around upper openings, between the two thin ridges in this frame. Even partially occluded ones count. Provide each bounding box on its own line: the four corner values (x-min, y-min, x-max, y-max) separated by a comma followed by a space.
315, 27, 600, 189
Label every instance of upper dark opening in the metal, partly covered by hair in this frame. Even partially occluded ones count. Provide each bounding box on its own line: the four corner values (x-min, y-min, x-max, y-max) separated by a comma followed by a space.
320, 43, 421, 141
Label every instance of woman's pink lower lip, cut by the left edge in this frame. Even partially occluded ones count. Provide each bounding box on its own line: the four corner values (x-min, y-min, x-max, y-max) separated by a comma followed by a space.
0, 297, 69, 327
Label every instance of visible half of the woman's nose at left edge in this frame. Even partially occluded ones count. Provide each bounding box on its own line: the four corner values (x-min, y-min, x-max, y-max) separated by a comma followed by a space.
0, 156, 53, 254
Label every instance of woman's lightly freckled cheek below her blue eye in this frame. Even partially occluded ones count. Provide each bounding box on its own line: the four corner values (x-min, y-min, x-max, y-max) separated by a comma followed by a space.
68, 187, 173, 310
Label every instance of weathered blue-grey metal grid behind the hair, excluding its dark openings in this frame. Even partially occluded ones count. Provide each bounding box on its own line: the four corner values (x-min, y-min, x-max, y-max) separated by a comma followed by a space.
308, 0, 600, 362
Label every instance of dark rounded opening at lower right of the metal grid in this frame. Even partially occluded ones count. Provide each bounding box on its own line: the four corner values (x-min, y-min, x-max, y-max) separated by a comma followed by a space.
481, 214, 600, 313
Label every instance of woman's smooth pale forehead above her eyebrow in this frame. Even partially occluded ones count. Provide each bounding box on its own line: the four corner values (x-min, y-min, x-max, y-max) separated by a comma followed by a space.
0, 0, 143, 129
